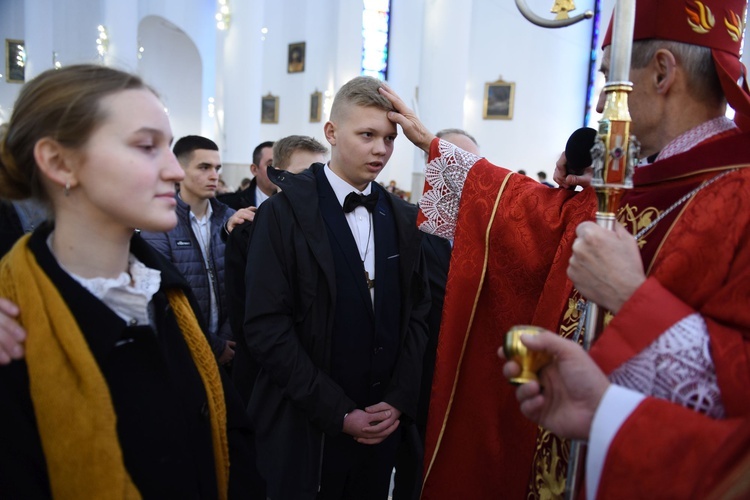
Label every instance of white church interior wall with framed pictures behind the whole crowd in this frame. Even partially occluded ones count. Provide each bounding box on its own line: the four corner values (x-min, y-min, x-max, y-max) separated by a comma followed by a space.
0, 0, 747, 192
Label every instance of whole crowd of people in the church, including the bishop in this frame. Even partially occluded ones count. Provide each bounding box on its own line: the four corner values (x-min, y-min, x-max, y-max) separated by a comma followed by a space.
0, 0, 750, 500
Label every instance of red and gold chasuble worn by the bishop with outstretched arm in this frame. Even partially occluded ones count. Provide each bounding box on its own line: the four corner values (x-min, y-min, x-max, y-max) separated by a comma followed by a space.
419, 133, 750, 500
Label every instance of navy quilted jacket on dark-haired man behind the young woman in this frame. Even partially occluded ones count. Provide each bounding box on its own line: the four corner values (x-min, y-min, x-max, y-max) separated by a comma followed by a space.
141, 196, 235, 357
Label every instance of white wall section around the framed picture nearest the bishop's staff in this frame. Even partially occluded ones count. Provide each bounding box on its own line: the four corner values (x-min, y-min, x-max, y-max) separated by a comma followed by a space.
464, 0, 604, 177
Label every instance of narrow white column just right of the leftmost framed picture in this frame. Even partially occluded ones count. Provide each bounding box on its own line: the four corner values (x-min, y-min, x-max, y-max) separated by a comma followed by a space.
24, 0, 53, 82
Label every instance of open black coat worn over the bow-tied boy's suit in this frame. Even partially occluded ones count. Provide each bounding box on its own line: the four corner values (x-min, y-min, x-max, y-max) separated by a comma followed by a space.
244, 164, 430, 499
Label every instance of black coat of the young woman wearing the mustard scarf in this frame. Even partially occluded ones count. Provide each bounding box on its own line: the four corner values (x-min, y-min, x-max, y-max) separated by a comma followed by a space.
0, 225, 250, 498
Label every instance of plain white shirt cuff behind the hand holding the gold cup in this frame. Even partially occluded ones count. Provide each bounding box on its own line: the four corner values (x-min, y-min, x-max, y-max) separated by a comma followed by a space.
586, 384, 646, 499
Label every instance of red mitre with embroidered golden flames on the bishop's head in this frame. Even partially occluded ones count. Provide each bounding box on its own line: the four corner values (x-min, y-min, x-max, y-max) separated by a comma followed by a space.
602, 0, 750, 130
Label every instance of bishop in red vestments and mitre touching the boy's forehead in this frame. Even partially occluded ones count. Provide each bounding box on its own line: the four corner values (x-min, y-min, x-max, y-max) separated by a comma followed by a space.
383, 0, 750, 499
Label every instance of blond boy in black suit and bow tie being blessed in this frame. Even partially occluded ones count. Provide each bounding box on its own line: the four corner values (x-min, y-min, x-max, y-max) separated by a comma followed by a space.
244, 77, 430, 500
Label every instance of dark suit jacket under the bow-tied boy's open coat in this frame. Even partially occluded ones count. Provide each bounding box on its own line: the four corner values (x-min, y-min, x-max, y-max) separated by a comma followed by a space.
316, 169, 401, 409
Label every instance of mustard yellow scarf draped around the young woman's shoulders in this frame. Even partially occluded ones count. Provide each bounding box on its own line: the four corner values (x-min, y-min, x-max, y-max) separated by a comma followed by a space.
0, 235, 229, 500
